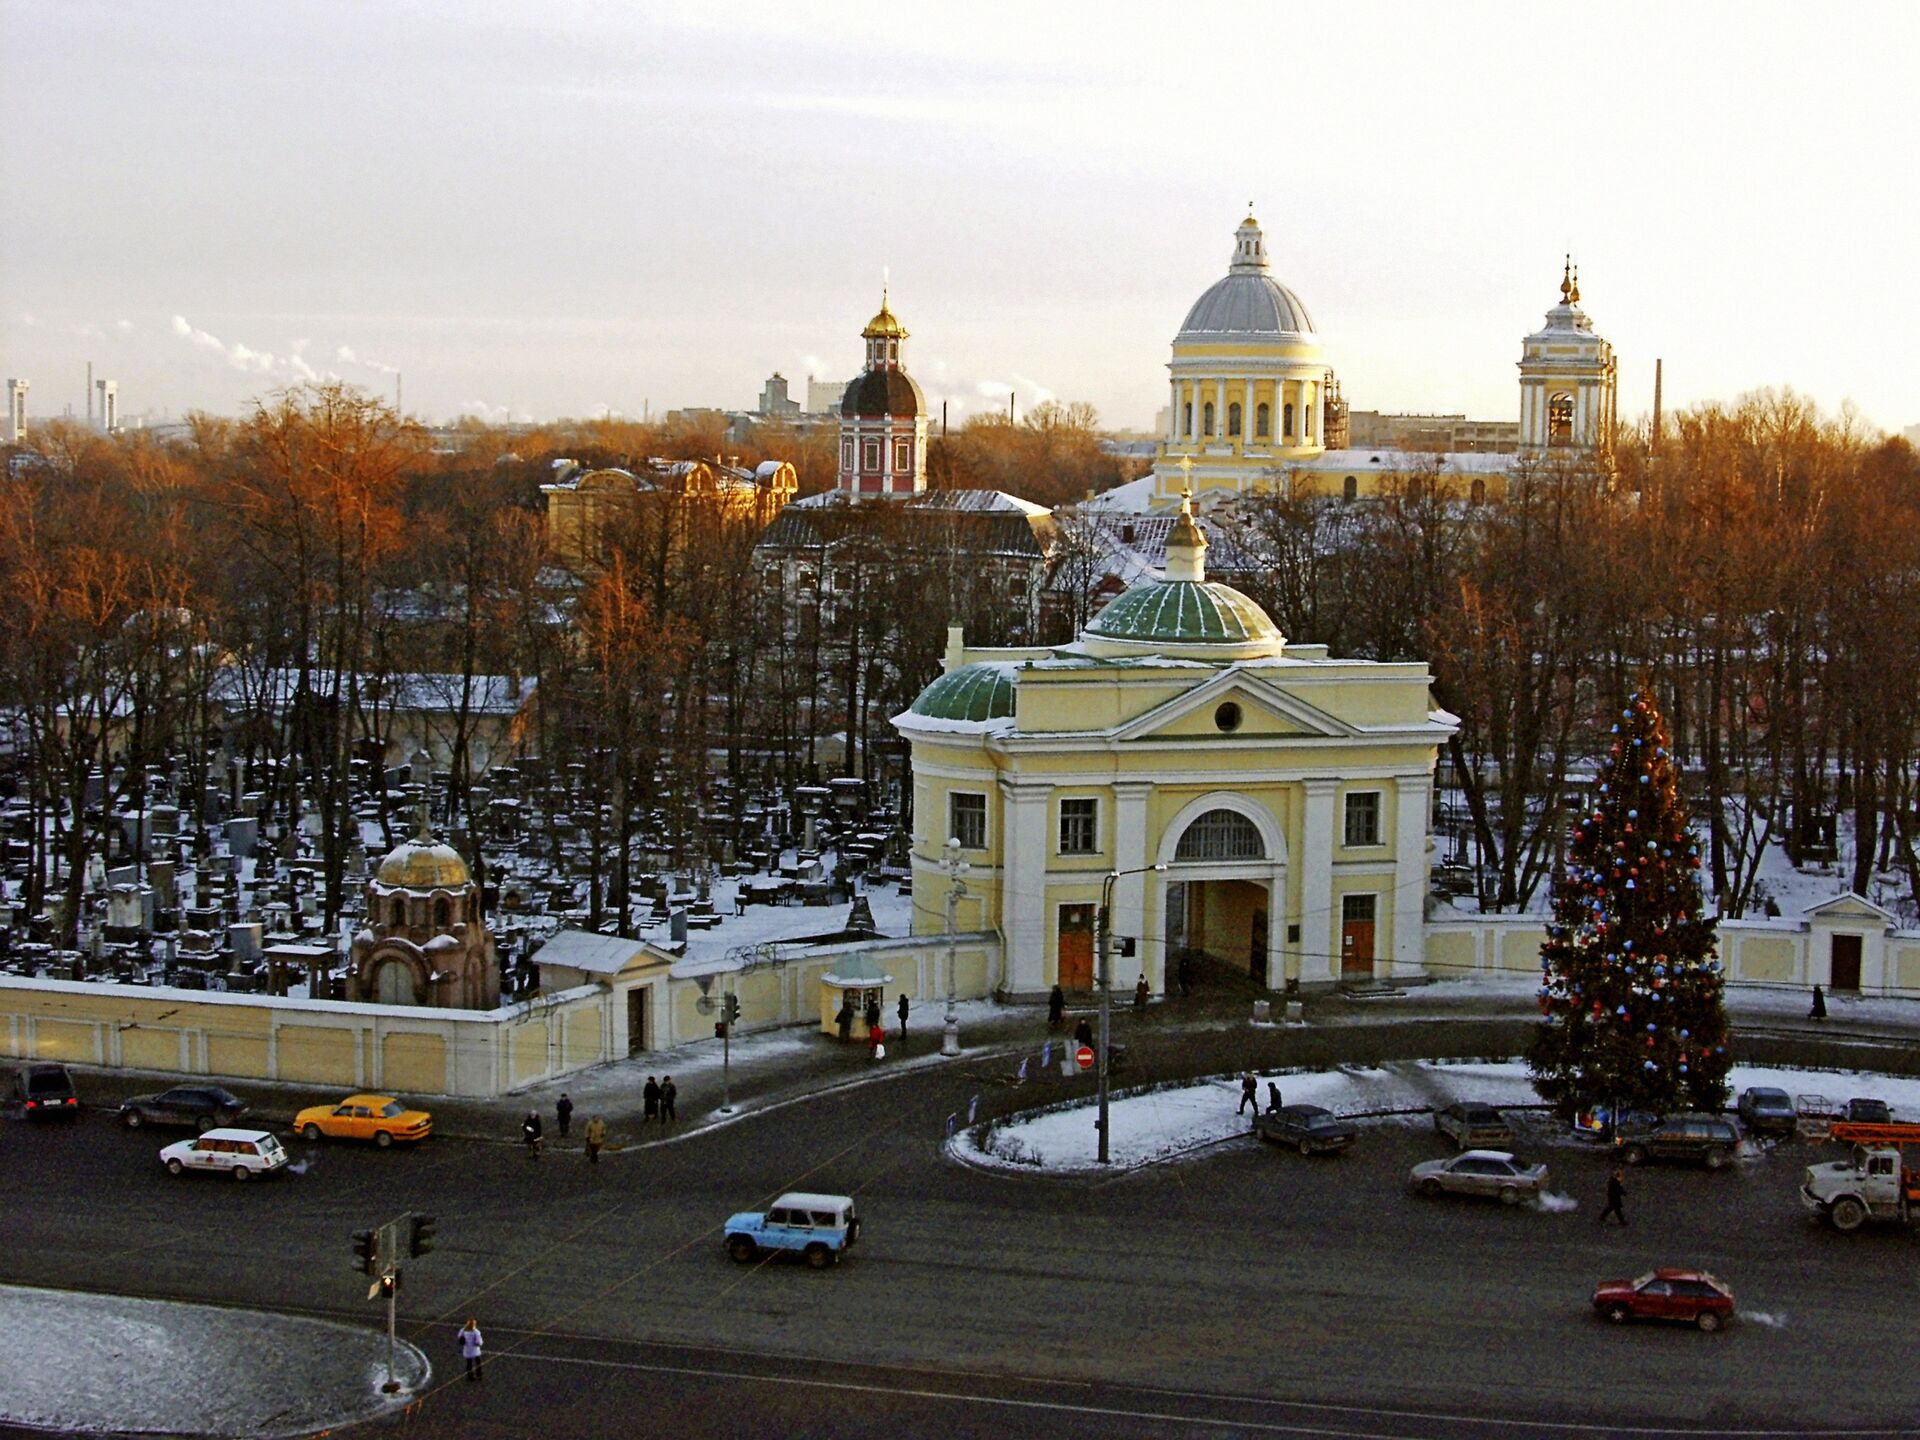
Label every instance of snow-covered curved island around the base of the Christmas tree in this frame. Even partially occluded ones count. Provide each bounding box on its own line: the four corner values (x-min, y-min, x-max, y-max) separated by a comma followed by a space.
947, 1060, 1920, 1175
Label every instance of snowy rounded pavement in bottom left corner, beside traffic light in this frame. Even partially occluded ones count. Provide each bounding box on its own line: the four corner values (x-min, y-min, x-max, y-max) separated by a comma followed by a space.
0, 1284, 432, 1440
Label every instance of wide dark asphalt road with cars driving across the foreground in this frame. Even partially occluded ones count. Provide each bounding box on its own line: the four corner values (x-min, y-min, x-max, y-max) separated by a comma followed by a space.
0, 1069, 1920, 1440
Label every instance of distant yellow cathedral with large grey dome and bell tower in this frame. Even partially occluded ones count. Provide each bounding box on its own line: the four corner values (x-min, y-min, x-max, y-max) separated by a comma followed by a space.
1136, 215, 1617, 513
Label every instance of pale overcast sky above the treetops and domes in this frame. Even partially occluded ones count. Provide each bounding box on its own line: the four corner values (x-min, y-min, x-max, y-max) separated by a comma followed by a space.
0, 0, 1920, 430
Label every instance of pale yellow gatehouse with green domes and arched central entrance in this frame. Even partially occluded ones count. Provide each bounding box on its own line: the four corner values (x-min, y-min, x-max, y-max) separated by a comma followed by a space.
893, 491, 1457, 998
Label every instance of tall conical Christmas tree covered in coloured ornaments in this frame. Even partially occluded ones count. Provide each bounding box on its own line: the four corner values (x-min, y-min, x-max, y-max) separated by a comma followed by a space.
1528, 693, 1732, 1116
